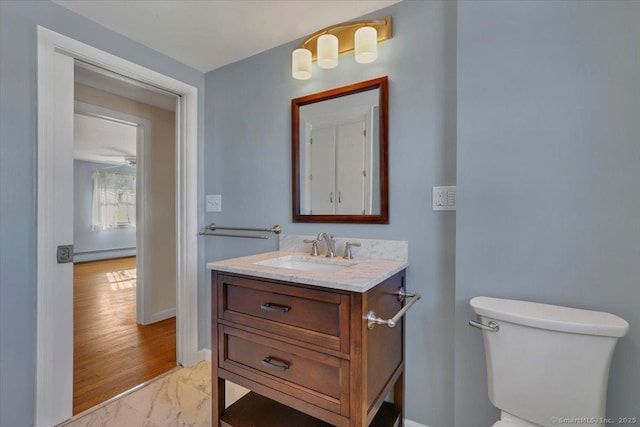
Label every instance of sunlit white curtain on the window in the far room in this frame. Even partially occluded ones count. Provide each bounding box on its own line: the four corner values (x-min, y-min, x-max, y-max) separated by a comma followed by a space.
91, 171, 136, 231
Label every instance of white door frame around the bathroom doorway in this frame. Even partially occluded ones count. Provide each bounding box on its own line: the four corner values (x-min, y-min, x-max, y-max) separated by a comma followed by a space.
35, 26, 198, 426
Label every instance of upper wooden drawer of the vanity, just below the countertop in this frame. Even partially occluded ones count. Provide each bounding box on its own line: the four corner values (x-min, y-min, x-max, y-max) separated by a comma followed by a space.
218, 275, 349, 353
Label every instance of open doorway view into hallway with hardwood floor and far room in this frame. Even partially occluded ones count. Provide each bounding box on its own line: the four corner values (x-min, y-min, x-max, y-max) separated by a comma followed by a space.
73, 67, 177, 415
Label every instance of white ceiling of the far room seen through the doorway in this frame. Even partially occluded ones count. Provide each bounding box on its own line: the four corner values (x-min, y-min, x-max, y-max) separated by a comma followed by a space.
73, 113, 138, 164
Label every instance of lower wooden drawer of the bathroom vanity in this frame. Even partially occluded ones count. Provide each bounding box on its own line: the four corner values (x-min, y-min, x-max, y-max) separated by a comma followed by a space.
218, 326, 349, 414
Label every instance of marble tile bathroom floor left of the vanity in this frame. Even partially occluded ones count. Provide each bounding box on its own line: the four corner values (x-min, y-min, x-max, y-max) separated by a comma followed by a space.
60, 362, 248, 427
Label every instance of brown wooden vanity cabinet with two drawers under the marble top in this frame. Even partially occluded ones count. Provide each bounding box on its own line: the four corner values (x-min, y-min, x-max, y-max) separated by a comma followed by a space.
211, 270, 405, 427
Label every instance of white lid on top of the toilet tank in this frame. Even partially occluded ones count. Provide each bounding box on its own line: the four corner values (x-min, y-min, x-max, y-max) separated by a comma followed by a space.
469, 297, 629, 337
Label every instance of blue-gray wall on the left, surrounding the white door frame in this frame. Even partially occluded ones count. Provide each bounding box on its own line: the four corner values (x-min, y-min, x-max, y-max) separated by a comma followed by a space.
0, 0, 204, 427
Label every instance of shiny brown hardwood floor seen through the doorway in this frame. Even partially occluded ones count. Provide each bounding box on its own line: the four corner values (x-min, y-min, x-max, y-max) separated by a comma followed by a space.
73, 257, 176, 414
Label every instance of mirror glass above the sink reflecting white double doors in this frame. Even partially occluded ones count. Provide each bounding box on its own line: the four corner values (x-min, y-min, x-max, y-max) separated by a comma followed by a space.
300, 90, 380, 215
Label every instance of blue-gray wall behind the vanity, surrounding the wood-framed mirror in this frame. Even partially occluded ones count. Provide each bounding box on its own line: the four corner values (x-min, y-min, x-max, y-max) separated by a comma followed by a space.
200, 1, 456, 427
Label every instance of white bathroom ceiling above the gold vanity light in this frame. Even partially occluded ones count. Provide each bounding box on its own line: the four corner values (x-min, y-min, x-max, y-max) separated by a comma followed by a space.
52, 0, 401, 73
